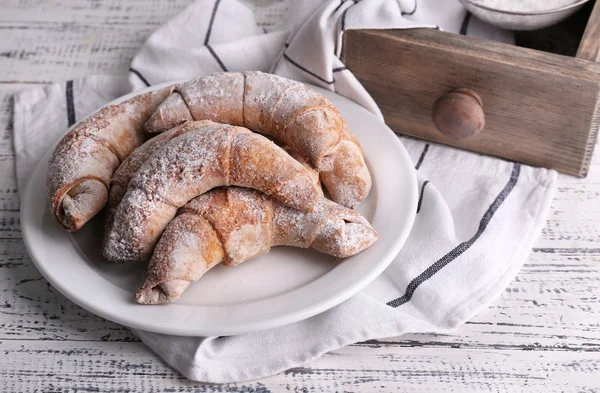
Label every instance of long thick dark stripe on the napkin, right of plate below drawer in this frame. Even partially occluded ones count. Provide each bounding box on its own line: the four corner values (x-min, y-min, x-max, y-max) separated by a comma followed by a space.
387, 163, 521, 307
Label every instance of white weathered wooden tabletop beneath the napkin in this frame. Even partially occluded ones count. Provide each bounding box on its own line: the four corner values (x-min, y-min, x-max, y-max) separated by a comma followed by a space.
0, 0, 600, 393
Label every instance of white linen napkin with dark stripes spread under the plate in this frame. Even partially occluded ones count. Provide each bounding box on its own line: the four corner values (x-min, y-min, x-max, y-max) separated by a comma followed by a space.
14, 0, 556, 382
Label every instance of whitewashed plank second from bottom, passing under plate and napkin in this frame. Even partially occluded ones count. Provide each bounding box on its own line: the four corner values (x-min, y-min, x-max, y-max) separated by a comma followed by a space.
0, 239, 600, 346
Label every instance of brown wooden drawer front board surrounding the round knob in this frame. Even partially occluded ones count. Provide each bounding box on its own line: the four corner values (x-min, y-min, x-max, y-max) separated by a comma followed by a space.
344, 29, 600, 176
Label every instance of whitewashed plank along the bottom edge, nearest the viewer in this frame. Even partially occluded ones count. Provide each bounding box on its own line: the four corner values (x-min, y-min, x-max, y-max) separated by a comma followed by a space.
0, 341, 600, 393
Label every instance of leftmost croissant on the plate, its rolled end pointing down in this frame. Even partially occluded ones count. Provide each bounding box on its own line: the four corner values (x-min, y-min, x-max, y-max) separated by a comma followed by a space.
46, 86, 173, 231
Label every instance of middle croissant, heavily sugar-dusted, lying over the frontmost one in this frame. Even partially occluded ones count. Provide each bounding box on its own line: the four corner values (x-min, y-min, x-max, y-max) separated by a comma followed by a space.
103, 122, 322, 262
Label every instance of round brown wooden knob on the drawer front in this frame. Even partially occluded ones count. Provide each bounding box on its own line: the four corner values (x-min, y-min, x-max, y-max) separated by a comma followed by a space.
431, 88, 485, 140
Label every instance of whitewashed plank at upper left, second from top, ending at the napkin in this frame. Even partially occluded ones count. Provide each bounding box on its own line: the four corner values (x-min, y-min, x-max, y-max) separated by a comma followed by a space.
0, 22, 168, 82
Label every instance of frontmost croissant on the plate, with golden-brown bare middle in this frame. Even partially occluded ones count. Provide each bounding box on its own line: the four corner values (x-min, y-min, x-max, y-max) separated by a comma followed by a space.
136, 187, 378, 304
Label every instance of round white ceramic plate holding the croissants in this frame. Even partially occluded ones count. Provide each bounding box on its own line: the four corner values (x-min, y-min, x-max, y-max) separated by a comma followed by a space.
21, 84, 418, 336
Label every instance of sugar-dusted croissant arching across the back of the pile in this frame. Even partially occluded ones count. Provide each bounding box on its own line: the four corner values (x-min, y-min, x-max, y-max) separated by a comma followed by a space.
146, 72, 371, 207
